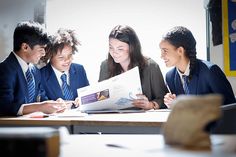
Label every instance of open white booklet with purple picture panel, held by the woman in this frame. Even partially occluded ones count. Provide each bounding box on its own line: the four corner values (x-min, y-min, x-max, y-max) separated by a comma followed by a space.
77, 67, 142, 112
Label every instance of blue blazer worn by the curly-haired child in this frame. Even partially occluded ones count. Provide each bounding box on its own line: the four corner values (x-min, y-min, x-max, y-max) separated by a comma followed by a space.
40, 63, 89, 100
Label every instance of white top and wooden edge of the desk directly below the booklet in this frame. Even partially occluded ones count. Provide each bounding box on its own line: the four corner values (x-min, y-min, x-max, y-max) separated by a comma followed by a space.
71, 111, 169, 126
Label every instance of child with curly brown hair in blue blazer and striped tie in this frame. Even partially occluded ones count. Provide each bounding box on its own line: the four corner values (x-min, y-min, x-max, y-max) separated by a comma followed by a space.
40, 28, 89, 105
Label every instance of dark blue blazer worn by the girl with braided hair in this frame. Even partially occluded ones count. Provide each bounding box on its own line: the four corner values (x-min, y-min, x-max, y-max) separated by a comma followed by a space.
166, 60, 235, 104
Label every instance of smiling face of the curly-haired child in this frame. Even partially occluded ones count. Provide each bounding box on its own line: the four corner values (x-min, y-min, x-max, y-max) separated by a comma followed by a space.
50, 45, 73, 72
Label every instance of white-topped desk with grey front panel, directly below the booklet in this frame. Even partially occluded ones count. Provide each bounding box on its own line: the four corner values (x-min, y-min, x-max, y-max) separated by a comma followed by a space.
71, 110, 169, 134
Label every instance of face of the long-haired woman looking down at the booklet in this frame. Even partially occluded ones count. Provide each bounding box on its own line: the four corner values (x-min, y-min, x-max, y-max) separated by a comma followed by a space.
109, 38, 130, 68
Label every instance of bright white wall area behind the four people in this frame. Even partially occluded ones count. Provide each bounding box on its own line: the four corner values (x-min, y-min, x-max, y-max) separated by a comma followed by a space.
46, 0, 206, 84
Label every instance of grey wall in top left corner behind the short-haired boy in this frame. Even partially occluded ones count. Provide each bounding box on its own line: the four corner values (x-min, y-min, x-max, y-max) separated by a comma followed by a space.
0, 0, 46, 61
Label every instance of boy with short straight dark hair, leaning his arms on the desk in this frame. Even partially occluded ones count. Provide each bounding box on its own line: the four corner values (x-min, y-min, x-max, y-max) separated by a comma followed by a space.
0, 21, 65, 116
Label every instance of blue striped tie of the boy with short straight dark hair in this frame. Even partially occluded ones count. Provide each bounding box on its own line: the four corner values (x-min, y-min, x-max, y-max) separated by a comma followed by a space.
25, 68, 35, 103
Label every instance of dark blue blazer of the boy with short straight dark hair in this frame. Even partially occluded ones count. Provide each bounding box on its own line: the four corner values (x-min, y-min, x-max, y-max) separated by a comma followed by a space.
0, 52, 47, 116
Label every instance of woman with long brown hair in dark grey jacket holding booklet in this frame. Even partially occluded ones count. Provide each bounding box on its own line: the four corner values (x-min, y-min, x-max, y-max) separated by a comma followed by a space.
99, 25, 168, 110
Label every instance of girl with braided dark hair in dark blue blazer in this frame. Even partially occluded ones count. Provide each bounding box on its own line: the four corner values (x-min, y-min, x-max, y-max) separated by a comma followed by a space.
159, 26, 235, 107
